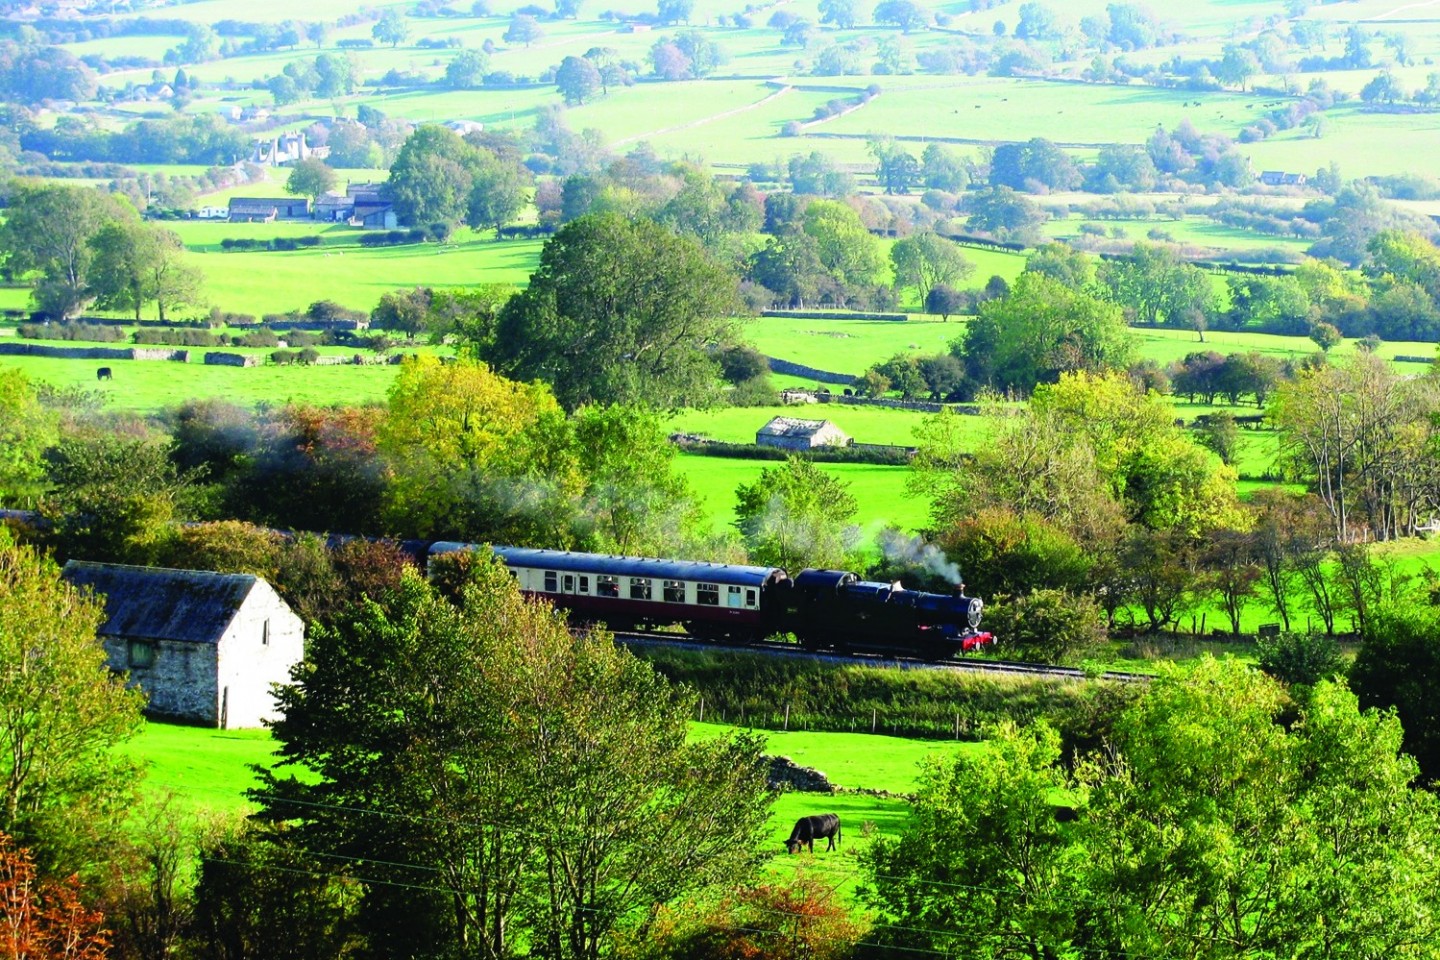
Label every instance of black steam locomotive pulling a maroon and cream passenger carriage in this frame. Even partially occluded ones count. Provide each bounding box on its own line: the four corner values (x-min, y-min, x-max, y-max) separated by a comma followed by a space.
426, 541, 995, 661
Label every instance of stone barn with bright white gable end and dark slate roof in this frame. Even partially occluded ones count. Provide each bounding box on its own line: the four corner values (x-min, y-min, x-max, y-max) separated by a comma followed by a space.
63, 560, 305, 730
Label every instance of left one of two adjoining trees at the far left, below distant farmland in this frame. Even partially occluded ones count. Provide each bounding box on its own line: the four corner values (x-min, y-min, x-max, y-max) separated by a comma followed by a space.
0, 184, 137, 320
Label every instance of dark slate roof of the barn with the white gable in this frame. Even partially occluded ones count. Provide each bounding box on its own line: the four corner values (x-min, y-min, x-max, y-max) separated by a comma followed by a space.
62, 560, 259, 643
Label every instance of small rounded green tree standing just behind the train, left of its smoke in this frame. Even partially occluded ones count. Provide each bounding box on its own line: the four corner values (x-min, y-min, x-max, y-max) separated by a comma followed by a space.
734, 456, 858, 571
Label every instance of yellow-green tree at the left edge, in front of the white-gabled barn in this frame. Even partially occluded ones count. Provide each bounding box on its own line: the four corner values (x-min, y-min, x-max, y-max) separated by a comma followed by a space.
0, 534, 144, 880
